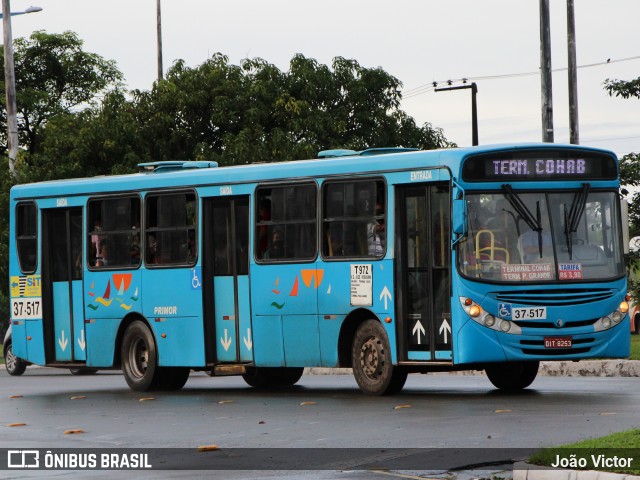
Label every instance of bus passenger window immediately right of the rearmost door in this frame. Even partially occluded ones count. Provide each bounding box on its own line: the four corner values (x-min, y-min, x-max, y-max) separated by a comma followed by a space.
87, 196, 141, 269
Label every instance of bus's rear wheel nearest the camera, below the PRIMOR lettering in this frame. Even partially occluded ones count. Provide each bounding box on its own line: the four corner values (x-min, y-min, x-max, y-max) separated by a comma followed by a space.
120, 320, 159, 392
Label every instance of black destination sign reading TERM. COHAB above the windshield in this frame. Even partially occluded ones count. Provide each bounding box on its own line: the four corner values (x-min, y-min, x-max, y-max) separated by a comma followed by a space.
462, 151, 617, 182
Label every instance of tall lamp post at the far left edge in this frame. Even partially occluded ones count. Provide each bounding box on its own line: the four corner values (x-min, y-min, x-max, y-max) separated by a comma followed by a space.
2, 0, 42, 177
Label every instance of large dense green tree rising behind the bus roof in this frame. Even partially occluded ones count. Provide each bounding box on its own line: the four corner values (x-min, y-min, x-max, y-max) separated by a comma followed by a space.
121, 54, 450, 165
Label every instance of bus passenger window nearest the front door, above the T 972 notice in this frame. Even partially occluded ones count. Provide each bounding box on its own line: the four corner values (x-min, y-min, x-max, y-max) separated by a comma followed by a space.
322, 180, 387, 258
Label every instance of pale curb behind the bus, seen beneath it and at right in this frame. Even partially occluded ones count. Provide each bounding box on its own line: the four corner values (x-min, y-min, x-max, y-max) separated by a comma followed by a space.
304, 360, 640, 378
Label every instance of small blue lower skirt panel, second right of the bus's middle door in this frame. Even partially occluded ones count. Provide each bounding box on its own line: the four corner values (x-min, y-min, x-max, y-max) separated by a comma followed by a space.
282, 315, 320, 367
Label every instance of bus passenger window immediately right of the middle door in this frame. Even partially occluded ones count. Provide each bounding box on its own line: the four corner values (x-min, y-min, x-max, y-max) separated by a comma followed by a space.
255, 183, 317, 262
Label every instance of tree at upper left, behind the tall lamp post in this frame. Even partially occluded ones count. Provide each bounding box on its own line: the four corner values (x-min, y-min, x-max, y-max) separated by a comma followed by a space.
0, 31, 122, 159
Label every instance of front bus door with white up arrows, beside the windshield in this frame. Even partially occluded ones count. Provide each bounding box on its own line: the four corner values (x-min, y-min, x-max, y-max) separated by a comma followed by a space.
395, 184, 453, 361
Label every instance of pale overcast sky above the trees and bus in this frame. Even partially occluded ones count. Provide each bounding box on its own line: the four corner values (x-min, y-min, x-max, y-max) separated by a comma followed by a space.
5, 0, 640, 156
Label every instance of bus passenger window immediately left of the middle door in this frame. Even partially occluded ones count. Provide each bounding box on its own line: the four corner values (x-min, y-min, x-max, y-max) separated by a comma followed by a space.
145, 192, 197, 266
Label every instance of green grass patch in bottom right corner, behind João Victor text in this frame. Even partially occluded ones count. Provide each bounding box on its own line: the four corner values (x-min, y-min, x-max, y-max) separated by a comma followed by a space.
529, 429, 640, 475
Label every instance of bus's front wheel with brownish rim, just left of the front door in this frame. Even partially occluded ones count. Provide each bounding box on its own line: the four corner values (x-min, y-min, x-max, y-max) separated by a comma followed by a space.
351, 320, 407, 395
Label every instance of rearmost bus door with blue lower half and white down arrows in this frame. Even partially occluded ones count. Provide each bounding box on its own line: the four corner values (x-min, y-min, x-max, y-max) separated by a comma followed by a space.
42, 207, 87, 362
